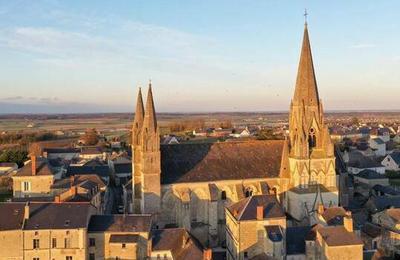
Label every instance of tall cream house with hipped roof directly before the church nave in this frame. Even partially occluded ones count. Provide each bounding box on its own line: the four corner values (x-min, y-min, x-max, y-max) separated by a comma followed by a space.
225, 195, 286, 260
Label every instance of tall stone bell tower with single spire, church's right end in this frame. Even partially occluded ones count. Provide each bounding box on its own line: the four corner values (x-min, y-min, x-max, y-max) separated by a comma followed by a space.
283, 23, 338, 221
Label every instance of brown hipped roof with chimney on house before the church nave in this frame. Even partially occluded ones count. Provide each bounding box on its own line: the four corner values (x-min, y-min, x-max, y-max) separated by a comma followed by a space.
227, 195, 286, 221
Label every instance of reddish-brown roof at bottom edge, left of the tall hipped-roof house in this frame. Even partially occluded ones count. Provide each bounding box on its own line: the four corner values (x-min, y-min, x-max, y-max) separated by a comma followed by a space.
152, 228, 203, 260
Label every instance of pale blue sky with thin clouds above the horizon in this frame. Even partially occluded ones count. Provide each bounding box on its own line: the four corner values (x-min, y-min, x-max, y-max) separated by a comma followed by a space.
0, 0, 400, 113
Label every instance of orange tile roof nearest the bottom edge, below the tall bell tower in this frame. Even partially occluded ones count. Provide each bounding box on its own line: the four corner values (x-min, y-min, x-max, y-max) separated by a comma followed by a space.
317, 226, 363, 246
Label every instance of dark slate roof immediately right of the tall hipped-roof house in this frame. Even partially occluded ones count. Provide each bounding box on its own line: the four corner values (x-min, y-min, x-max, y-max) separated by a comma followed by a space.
286, 227, 311, 255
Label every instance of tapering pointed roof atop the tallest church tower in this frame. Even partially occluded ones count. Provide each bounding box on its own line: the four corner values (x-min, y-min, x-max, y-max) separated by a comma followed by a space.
293, 23, 319, 105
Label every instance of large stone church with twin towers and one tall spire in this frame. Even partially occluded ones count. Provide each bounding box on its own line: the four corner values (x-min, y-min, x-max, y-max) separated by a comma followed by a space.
131, 23, 340, 247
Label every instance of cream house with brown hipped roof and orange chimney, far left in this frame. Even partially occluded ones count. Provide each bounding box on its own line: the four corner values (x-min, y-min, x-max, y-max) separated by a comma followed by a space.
12, 155, 61, 197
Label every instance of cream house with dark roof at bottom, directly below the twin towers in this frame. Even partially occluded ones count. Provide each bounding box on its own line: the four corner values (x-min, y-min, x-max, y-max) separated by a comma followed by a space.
87, 215, 152, 260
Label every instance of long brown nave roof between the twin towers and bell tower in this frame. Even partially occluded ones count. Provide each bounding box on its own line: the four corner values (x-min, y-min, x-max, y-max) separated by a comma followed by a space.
161, 140, 284, 184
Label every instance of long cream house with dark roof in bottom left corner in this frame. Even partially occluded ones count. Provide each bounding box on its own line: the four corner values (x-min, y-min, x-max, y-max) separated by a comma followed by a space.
0, 202, 95, 259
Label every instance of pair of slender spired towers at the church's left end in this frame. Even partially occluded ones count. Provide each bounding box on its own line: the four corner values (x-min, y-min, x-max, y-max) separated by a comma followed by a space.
132, 83, 161, 214
